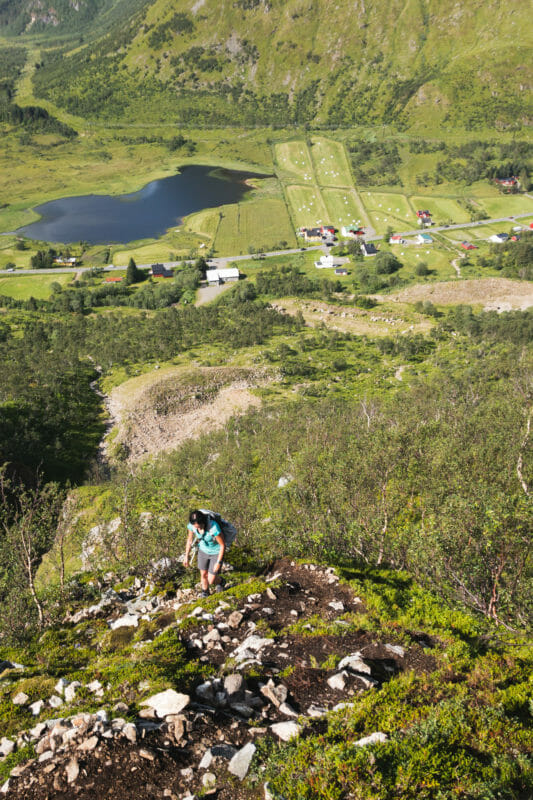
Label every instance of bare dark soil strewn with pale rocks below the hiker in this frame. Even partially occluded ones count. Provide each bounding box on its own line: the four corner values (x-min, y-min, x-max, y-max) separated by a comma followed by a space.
0, 561, 438, 800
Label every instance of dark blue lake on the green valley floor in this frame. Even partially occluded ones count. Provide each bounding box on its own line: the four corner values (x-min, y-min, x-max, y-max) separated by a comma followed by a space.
17, 165, 265, 244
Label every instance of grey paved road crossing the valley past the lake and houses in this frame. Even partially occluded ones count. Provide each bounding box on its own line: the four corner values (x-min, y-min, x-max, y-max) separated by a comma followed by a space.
5, 211, 533, 276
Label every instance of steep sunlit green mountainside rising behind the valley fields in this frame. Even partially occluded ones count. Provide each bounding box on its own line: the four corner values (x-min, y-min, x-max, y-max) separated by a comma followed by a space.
21, 0, 533, 128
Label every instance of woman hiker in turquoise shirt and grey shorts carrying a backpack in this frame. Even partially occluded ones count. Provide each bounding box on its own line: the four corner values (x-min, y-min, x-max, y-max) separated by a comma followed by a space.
183, 509, 226, 597
